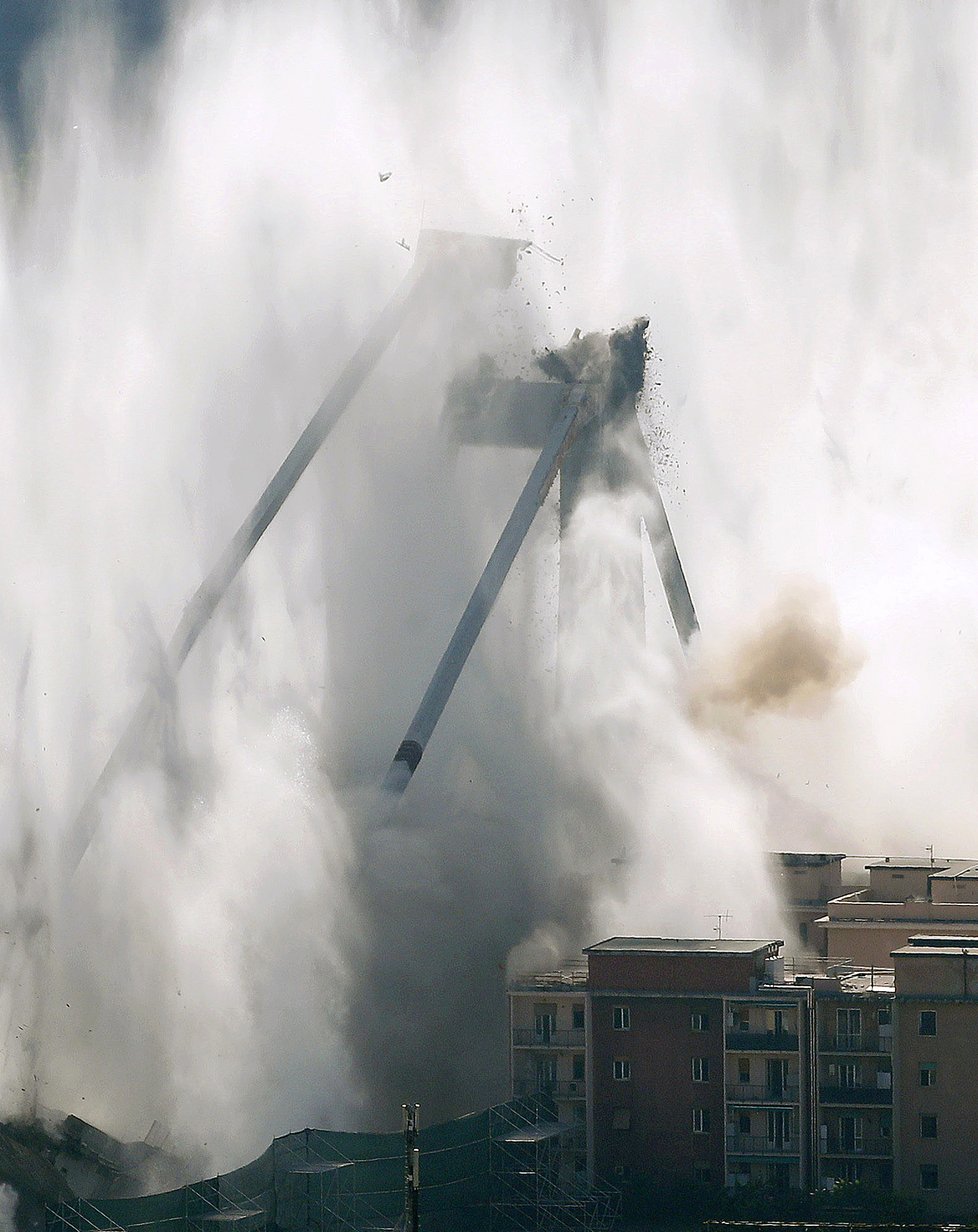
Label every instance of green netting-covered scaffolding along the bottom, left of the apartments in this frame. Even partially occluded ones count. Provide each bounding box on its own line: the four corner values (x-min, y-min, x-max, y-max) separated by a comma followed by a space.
47, 1096, 620, 1232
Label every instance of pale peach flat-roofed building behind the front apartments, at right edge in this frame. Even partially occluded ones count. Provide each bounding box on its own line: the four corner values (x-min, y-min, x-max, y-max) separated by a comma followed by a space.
814, 856, 978, 967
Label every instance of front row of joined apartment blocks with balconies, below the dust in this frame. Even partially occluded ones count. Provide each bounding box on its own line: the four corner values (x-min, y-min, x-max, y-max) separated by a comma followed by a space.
510, 936, 978, 1218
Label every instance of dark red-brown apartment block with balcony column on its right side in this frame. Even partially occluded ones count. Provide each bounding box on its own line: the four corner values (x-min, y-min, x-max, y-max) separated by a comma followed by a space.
585, 938, 812, 1191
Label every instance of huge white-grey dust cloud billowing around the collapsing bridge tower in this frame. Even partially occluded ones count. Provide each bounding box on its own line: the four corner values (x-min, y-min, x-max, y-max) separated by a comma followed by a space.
0, 0, 978, 1167
